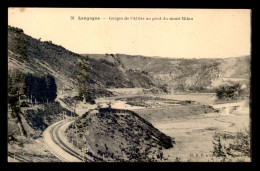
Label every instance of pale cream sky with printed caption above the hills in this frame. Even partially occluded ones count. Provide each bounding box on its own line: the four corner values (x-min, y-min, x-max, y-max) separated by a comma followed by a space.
8, 8, 251, 58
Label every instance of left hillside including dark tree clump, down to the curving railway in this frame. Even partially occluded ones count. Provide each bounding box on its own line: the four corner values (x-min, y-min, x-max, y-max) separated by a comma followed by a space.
8, 26, 161, 159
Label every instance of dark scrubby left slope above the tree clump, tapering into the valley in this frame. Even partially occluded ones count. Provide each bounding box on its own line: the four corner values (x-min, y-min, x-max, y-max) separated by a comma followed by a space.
8, 26, 158, 101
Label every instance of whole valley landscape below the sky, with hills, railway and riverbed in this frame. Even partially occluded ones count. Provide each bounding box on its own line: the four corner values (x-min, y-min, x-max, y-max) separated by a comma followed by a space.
7, 26, 251, 162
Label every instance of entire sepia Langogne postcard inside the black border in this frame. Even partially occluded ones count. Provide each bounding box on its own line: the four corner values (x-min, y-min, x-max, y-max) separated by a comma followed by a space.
7, 7, 252, 163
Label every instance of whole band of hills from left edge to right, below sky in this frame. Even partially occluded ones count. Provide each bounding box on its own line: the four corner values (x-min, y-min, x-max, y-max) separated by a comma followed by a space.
8, 26, 250, 100
